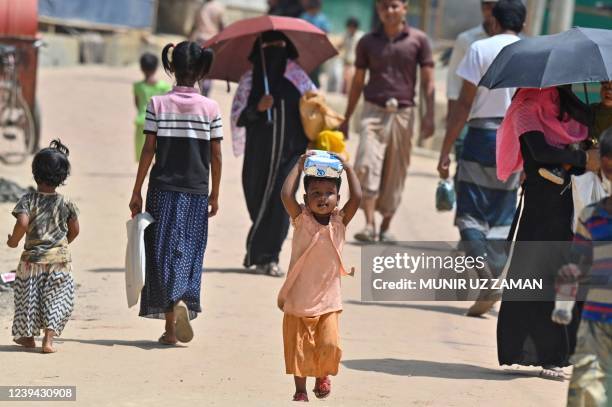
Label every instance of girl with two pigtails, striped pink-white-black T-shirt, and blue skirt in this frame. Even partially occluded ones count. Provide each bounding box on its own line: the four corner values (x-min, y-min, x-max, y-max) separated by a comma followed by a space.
129, 41, 223, 345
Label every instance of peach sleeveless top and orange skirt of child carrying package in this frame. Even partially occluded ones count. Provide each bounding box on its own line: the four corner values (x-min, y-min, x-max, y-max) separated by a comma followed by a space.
278, 206, 347, 377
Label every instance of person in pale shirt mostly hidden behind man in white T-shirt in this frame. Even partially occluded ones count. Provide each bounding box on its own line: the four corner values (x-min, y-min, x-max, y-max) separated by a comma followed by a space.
446, 0, 497, 163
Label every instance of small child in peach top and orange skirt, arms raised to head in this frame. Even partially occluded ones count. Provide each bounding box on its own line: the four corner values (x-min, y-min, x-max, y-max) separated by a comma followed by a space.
278, 154, 361, 401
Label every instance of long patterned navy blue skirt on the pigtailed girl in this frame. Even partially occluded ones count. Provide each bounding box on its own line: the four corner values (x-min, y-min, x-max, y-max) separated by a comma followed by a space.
139, 186, 208, 319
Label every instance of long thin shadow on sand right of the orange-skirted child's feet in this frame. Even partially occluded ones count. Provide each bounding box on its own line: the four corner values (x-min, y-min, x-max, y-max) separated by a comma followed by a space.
342, 358, 536, 381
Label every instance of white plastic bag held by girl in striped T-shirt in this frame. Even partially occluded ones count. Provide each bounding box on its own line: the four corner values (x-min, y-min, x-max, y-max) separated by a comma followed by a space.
125, 212, 155, 307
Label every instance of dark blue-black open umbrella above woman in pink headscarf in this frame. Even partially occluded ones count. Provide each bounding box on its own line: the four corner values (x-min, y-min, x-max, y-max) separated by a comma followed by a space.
479, 27, 612, 89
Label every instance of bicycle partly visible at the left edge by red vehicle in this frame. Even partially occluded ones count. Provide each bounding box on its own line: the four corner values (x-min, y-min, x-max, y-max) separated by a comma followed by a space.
0, 44, 40, 164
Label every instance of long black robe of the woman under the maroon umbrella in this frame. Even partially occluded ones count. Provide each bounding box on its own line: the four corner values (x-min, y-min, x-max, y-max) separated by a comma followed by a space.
238, 69, 308, 267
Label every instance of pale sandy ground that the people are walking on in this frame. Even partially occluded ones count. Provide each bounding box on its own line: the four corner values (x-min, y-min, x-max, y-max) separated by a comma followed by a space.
0, 67, 567, 406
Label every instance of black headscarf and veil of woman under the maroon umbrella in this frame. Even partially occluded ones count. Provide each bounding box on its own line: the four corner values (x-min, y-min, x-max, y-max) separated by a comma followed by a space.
249, 31, 298, 103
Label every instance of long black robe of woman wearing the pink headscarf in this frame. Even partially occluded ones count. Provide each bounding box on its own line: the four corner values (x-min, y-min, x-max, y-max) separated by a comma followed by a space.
497, 132, 586, 367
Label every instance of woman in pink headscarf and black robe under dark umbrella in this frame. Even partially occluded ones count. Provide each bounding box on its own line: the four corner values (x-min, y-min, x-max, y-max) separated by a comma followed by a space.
480, 27, 612, 380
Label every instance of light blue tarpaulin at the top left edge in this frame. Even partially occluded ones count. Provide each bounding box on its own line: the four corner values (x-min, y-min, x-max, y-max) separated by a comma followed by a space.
38, 0, 156, 28
